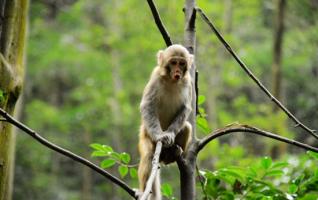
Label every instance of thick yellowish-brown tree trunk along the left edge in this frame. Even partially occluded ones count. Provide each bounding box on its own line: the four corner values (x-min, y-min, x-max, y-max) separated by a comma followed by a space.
0, 0, 28, 200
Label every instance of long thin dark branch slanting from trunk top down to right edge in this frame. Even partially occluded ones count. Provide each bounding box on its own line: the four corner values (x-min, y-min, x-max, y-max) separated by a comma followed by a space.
197, 8, 318, 139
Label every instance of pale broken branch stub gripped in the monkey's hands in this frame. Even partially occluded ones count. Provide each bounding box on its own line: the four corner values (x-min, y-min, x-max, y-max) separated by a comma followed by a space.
140, 141, 162, 200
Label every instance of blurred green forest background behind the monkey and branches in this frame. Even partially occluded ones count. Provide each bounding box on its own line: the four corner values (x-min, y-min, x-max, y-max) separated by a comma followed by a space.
13, 0, 318, 200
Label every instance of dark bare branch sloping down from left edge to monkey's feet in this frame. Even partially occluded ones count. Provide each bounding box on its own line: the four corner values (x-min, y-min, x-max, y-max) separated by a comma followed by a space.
0, 108, 137, 199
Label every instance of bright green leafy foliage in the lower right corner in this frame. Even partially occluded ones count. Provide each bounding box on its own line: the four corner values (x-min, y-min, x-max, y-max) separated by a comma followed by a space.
200, 152, 318, 199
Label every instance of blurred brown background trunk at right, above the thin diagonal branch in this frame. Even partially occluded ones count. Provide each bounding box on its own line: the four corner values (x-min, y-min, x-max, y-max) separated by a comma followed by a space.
272, 0, 286, 112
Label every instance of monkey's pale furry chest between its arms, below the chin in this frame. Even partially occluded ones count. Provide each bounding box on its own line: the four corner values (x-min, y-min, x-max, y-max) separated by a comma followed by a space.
157, 89, 186, 130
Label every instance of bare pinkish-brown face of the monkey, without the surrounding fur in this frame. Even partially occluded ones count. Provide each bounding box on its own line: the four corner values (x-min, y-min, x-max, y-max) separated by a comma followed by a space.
166, 57, 188, 82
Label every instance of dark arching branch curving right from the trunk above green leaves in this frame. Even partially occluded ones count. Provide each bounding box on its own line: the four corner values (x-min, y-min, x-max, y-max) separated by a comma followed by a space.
196, 124, 318, 152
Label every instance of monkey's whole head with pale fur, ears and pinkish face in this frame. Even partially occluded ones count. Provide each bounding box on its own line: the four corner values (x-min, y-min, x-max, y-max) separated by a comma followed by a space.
157, 44, 193, 82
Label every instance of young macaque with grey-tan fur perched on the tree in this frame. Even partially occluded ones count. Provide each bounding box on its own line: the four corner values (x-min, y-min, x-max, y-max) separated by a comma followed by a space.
138, 44, 193, 200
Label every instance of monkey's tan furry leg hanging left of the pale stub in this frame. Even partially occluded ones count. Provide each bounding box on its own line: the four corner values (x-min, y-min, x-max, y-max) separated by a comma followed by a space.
138, 136, 154, 192
